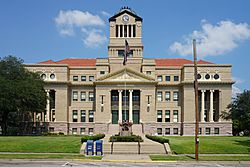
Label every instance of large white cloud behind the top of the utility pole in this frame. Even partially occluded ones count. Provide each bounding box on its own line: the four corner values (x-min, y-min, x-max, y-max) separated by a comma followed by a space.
169, 20, 250, 58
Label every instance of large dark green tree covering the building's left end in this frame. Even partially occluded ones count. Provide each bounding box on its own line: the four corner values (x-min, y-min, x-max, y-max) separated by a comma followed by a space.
0, 56, 46, 135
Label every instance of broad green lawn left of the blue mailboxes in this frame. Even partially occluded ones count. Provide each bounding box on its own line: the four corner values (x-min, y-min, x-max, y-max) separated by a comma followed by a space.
0, 136, 81, 153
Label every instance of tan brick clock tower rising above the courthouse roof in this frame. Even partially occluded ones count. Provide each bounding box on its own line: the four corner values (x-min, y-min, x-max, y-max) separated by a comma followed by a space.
108, 7, 143, 70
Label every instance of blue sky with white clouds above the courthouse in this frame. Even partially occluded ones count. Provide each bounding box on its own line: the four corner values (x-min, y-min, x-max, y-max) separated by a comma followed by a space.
0, 0, 250, 95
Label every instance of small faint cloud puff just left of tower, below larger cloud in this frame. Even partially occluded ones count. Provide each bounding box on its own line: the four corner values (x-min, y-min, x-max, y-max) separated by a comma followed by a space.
82, 29, 107, 48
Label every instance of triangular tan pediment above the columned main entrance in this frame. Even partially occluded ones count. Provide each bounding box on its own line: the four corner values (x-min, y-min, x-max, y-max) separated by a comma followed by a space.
96, 68, 155, 83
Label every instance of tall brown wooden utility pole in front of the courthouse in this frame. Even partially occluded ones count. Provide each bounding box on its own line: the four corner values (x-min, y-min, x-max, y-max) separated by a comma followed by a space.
193, 39, 199, 161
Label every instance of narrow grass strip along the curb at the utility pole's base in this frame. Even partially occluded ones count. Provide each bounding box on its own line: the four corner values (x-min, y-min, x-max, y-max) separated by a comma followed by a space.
150, 155, 250, 161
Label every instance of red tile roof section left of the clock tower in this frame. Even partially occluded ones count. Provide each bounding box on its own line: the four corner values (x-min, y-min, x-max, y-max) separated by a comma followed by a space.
38, 59, 96, 66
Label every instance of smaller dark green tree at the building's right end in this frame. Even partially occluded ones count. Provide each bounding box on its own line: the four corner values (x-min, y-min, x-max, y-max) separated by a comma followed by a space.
221, 90, 250, 135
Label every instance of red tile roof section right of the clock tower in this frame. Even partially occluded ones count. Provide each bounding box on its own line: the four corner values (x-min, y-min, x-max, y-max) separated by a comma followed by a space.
155, 58, 213, 67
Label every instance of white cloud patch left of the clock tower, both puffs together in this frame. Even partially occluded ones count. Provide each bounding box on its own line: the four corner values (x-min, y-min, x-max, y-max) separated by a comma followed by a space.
54, 10, 108, 48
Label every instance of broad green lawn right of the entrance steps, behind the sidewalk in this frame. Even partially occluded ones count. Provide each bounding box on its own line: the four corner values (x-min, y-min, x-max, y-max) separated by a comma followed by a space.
166, 136, 250, 154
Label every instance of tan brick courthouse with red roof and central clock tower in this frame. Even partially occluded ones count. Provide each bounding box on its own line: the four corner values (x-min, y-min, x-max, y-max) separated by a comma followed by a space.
26, 8, 233, 135
